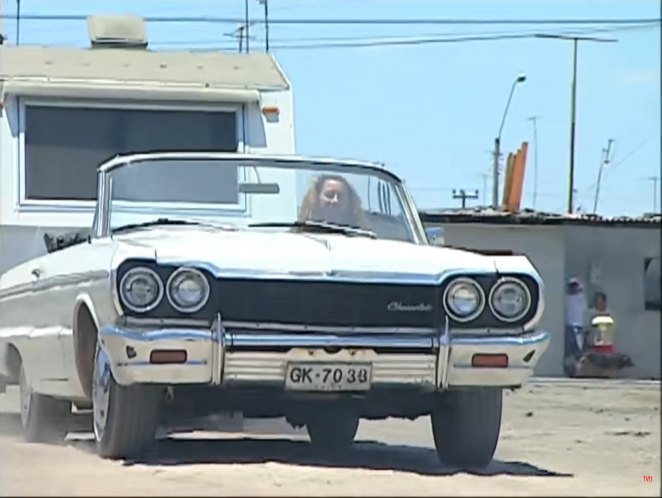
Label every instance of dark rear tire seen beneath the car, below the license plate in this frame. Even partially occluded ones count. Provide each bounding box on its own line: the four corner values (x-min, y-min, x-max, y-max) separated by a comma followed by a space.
306, 409, 359, 454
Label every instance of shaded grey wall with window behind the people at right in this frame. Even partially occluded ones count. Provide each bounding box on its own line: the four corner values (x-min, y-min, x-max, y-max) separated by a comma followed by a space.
565, 226, 662, 379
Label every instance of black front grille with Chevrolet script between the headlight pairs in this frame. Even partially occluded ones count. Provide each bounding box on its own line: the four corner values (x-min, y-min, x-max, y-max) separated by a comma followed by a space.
215, 279, 443, 327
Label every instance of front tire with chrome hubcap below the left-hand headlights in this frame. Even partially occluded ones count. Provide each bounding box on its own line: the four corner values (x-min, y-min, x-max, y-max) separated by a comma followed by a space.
92, 344, 161, 459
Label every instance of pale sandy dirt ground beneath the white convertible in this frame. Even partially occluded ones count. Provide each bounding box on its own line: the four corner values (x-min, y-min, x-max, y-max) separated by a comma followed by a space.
0, 380, 662, 496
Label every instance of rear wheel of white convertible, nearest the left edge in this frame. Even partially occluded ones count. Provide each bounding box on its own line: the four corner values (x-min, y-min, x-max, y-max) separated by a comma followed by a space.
19, 364, 71, 443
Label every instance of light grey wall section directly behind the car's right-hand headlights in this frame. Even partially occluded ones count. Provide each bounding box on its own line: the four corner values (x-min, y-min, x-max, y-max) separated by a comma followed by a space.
426, 223, 565, 376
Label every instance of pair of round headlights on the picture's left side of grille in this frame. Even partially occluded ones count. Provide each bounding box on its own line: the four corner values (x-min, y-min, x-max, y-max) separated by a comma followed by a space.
119, 266, 210, 313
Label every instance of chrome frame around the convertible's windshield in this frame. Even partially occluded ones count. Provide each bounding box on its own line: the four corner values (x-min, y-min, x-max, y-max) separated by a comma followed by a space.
92, 152, 428, 245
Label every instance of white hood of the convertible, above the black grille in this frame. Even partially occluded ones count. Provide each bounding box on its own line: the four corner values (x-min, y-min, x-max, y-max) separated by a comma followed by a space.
115, 227, 504, 282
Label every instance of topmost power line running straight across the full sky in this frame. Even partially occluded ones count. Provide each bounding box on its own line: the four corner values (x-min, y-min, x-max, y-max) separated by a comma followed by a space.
0, 14, 662, 26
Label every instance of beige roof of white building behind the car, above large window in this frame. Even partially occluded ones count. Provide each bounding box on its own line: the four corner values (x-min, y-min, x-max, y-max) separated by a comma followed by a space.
0, 45, 290, 90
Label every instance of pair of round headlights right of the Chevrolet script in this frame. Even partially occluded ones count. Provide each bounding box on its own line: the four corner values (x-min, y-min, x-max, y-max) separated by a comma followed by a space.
443, 277, 533, 323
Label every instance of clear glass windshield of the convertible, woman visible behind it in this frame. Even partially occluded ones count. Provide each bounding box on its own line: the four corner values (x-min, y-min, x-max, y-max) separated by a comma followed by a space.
108, 158, 421, 242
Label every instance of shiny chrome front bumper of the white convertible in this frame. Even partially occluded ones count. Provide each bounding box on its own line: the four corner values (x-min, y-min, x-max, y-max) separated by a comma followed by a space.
100, 320, 549, 390
